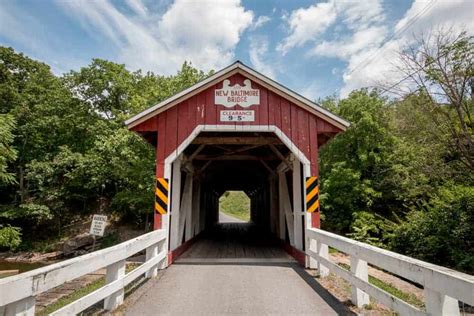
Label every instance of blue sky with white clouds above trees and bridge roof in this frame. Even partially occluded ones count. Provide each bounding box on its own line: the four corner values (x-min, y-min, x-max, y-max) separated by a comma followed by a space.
0, 0, 474, 100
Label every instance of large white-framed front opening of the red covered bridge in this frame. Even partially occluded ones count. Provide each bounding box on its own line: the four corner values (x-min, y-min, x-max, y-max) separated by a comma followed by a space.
169, 131, 305, 258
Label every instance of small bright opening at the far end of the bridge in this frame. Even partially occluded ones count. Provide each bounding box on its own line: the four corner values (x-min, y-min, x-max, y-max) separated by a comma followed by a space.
219, 191, 251, 223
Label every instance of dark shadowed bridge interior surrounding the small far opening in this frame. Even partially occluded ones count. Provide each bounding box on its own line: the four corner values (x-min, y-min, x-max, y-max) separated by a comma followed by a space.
184, 132, 289, 231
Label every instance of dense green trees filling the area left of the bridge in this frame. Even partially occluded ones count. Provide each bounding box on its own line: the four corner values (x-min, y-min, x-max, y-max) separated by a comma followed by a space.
0, 47, 208, 249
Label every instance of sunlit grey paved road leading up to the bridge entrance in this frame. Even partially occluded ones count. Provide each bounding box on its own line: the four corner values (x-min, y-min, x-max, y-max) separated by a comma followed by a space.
125, 259, 347, 316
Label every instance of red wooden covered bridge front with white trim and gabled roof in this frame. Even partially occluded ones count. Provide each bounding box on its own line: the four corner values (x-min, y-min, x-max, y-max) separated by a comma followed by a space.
126, 62, 349, 263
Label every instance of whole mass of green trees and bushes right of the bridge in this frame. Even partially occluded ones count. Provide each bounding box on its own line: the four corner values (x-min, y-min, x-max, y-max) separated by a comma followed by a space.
320, 29, 474, 273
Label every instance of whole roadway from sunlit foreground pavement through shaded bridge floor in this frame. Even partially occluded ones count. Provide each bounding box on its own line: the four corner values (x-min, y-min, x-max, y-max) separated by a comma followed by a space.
125, 224, 348, 315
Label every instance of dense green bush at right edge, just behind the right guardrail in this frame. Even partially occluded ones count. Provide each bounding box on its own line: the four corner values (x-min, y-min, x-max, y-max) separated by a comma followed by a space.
392, 185, 474, 273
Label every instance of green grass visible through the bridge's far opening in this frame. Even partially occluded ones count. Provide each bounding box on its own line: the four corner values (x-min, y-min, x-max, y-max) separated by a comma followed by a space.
219, 191, 250, 222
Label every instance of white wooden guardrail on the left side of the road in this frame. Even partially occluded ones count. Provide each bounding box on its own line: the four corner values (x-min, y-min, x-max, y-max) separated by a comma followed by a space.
0, 230, 167, 316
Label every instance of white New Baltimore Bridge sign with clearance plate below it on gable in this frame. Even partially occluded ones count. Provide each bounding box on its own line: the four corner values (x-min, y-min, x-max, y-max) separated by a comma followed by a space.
214, 79, 260, 122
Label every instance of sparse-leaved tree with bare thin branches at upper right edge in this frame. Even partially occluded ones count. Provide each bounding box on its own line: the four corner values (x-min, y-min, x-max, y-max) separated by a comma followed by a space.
400, 30, 474, 171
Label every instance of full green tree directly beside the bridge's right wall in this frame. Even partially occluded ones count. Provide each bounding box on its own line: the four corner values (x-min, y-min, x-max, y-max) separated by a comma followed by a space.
320, 90, 409, 233
